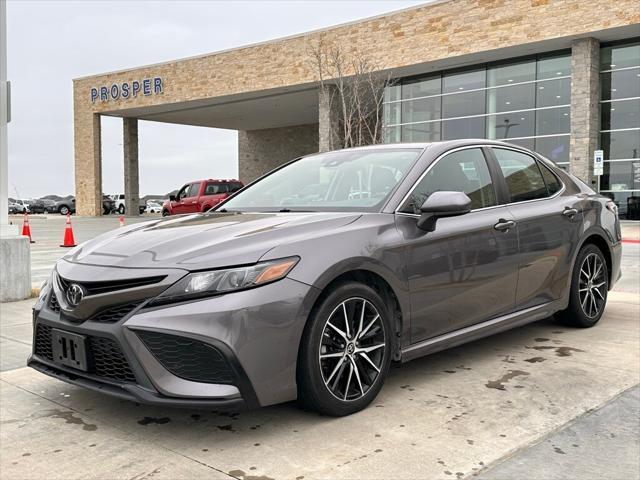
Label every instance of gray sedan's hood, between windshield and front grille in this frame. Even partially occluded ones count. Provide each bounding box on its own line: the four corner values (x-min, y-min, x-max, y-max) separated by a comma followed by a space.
63, 212, 361, 270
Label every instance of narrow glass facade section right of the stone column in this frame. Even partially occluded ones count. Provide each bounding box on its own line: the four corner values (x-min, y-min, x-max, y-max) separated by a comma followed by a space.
600, 40, 640, 220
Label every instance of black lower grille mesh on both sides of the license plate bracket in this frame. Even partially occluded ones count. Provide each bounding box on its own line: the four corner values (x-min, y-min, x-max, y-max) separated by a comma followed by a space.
35, 323, 136, 383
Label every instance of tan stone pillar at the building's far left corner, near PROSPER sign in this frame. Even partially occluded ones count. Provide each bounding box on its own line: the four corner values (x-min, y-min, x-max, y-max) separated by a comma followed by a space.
73, 110, 102, 216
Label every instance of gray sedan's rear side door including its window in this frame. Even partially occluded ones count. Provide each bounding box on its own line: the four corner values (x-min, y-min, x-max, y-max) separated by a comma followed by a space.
492, 147, 583, 308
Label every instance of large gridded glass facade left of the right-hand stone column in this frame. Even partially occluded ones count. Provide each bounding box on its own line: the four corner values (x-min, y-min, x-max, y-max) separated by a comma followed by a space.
383, 51, 571, 168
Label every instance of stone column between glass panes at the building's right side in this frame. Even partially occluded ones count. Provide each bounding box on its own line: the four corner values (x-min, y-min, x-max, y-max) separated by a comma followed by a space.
570, 38, 600, 188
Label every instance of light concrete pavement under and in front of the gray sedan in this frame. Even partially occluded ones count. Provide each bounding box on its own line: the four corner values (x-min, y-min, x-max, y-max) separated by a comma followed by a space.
0, 292, 640, 480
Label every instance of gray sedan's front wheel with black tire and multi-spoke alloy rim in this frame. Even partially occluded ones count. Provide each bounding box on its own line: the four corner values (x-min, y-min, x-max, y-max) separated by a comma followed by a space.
297, 282, 393, 417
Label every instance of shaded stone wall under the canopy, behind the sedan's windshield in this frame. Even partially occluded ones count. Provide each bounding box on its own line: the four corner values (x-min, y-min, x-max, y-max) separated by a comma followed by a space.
238, 123, 318, 184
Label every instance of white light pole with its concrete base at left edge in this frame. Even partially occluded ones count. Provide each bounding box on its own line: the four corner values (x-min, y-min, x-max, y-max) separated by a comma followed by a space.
0, 0, 31, 302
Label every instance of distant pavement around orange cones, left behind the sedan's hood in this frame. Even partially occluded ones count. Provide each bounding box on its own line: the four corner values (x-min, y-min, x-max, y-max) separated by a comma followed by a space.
10, 214, 157, 288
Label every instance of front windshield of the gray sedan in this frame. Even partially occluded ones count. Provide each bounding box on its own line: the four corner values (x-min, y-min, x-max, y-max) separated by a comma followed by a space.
219, 148, 421, 211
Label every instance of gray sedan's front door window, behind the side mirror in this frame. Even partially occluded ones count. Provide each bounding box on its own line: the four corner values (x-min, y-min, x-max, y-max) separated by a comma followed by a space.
401, 148, 496, 213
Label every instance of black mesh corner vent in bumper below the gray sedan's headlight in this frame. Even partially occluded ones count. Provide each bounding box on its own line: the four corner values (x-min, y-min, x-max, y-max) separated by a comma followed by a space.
136, 330, 235, 384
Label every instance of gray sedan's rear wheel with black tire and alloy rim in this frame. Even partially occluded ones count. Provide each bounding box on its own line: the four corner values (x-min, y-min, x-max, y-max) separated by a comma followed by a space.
556, 244, 609, 328
